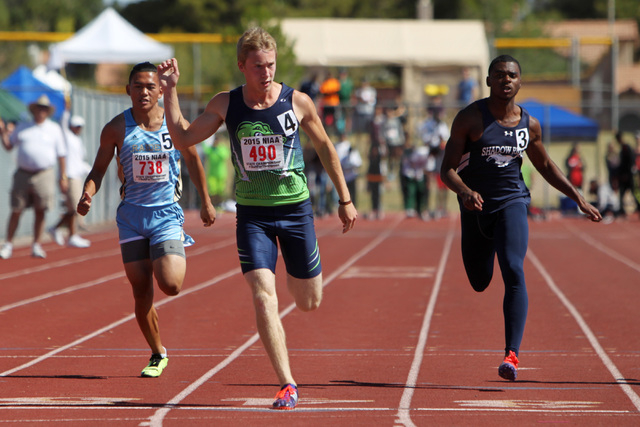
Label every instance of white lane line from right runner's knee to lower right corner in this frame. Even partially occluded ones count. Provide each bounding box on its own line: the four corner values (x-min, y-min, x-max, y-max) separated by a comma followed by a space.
527, 249, 640, 411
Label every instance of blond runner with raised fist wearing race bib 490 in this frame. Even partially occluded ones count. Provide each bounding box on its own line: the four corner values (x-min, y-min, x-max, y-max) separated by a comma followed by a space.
158, 28, 358, 410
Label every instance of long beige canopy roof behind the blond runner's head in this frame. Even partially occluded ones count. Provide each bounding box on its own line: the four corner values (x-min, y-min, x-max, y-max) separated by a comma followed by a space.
281, 18, 489, 69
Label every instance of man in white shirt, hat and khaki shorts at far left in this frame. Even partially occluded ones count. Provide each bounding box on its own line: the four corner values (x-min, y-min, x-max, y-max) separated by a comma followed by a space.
0, 95, 68, 259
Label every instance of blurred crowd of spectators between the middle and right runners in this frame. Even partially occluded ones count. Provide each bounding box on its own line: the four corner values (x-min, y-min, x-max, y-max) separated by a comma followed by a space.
300, 69, 479, 221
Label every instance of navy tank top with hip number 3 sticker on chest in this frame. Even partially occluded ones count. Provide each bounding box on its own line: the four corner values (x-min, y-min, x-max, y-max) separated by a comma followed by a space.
457, 98, 531, 214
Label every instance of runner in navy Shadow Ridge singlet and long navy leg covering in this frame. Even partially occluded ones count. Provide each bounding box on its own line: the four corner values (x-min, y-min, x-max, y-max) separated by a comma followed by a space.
440, 55, 602, 381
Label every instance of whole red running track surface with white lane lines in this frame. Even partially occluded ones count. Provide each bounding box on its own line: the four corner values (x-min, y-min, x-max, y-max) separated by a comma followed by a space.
0, 212, 640, 426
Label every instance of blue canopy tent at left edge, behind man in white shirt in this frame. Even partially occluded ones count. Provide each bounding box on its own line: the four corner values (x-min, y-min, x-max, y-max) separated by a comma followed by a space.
0, 65, 65, 120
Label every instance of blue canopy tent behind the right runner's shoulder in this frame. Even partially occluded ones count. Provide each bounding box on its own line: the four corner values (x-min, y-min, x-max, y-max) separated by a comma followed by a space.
519, 99, 599, 141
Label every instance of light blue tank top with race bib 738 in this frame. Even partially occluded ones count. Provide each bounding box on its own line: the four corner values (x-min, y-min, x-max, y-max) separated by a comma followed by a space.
118, 109, 182, 206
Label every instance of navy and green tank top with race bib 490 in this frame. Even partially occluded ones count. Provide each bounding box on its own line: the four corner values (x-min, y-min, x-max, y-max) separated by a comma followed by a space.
225, 84, 309, 206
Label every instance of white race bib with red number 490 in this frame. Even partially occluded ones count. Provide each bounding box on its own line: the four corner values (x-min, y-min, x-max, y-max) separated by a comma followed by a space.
240, 135, 284, 171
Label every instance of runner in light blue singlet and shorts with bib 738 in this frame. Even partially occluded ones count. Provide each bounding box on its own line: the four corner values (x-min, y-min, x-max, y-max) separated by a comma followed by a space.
77, 62, 216, 377
